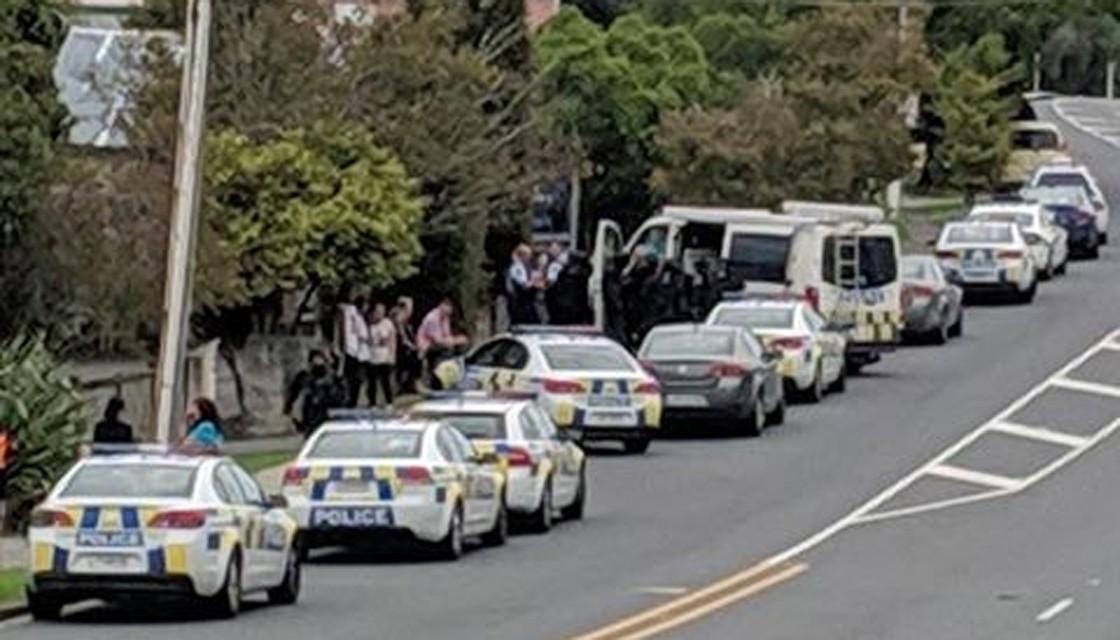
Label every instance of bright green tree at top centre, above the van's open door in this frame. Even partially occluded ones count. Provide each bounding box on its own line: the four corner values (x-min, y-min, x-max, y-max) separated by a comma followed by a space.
536, 9, 711, 233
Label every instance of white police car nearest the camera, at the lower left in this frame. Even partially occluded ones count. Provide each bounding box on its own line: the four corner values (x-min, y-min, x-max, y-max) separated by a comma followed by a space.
27, 453, 300, 620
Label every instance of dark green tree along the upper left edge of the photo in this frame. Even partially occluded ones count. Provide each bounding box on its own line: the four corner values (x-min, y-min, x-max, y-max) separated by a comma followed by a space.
0, 0, 65, 336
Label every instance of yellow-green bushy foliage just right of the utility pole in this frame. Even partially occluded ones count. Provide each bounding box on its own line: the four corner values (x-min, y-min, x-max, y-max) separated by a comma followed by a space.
204, 124, 423, 297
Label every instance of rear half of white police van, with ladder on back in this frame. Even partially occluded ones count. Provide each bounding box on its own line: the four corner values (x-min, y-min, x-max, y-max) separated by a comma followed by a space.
720, 202, 903, 369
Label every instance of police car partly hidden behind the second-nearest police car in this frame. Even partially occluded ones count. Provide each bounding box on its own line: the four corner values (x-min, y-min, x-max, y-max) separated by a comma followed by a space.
411, 393, 587, 532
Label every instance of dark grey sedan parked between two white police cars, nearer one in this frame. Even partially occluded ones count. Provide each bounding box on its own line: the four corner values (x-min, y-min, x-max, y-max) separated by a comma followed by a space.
638, 324, 785, 436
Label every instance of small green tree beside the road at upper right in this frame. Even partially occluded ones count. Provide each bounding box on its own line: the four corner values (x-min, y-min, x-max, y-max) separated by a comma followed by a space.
933, 34, 1020, 191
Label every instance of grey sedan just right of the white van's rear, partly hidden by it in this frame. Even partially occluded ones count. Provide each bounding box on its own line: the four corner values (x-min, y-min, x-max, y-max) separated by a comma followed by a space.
902, 256, 964, 344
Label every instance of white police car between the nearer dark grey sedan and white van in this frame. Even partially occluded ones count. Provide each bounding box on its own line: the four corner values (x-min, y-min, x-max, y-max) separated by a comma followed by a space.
708, 296, 848, 402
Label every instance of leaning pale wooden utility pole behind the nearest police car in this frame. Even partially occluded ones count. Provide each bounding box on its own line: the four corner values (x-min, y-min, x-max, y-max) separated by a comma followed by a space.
156, 0, 212, 443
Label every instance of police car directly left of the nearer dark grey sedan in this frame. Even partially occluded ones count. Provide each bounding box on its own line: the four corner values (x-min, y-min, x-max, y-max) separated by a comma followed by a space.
460, 327, 662, 453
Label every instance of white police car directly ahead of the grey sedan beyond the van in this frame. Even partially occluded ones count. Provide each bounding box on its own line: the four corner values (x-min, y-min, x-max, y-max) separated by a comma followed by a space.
936, 222, 1038, 303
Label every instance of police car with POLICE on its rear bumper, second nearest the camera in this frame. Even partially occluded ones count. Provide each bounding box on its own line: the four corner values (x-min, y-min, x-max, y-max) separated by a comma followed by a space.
283, 412, 508, 560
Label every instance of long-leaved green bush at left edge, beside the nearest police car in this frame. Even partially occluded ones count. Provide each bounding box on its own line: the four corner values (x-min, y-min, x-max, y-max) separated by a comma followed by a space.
0, 337, 86, 529
